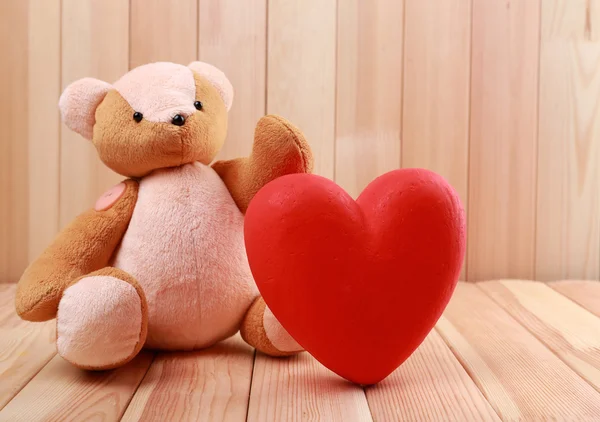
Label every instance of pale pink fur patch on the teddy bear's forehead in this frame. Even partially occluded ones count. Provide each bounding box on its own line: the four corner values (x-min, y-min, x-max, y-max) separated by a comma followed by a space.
115, 62, 196, 122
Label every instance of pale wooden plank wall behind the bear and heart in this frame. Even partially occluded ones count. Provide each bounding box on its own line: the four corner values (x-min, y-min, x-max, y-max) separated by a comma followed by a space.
0, 0, 600, 282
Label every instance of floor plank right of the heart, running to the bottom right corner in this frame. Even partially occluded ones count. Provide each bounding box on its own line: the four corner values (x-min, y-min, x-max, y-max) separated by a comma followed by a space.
437, 283, 600, 421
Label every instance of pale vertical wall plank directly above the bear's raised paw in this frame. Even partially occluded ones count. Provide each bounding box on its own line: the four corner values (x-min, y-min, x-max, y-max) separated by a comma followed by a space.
267, 0, 336, 179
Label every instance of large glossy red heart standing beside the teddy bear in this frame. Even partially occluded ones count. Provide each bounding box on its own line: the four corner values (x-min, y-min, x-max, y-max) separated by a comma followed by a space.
244, 169, 465, 385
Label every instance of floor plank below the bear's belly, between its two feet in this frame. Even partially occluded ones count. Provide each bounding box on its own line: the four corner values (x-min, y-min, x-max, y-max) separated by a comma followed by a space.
123, 335, 254, 422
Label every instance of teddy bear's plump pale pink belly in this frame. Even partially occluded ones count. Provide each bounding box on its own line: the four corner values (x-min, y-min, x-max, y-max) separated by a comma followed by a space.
114, 163, 258, 350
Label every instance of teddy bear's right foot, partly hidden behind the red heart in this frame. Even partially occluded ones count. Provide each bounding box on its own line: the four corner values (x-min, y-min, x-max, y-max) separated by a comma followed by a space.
240, 297, 304, 356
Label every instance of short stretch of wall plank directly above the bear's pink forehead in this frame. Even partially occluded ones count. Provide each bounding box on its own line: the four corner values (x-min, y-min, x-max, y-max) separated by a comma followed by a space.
129, 0, 198, 68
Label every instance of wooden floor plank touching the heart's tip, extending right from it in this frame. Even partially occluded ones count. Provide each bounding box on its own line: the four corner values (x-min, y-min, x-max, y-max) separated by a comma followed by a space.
366, 331, 500, 422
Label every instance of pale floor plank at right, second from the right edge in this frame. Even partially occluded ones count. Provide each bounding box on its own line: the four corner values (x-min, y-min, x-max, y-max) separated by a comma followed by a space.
478, 280, 600, 391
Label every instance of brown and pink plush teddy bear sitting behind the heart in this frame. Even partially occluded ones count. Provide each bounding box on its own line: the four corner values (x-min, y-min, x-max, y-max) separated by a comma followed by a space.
15, 61, 313, 370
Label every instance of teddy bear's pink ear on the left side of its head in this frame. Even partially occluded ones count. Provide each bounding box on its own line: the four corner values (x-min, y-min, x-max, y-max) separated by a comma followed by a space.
58, 78, 112, 140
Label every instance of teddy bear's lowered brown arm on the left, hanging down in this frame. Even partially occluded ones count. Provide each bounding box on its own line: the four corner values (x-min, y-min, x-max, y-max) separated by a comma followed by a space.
15, 180, 138, 321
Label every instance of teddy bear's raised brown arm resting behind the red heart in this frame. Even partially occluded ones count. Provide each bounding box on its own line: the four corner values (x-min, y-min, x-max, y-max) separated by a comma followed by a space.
212, 115, 313, 213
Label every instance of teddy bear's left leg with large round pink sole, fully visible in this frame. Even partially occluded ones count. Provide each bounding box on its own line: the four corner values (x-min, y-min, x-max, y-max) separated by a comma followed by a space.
56, 267, 148, 370
